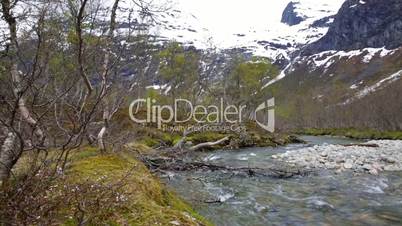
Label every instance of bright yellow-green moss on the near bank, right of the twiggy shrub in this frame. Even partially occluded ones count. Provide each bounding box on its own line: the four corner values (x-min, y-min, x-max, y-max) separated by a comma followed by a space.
65, 149, 210, 225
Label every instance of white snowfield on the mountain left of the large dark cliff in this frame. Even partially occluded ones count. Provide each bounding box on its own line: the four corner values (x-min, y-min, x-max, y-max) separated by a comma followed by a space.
148, 0, 344, 60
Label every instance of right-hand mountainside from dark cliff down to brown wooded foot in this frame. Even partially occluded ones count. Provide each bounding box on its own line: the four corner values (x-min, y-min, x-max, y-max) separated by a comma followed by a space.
268, 0, 402, 130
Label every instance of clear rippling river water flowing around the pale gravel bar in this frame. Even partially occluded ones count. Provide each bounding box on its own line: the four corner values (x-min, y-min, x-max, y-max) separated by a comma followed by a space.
160, 136, 402, 226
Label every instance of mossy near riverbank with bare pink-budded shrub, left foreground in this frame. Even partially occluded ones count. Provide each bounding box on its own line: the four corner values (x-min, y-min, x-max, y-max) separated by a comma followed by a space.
10, 147, 211, 226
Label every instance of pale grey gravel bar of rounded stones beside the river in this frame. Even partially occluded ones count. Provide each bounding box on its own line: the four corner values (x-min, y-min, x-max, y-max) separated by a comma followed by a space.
272, 140, 402, 175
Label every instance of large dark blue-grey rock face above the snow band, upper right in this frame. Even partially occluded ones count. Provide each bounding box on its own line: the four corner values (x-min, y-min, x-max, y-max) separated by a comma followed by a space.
302, 0, 402, 55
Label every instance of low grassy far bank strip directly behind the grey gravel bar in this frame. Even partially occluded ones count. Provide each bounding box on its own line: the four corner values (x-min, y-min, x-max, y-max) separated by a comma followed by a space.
294, 128, 402, 140
